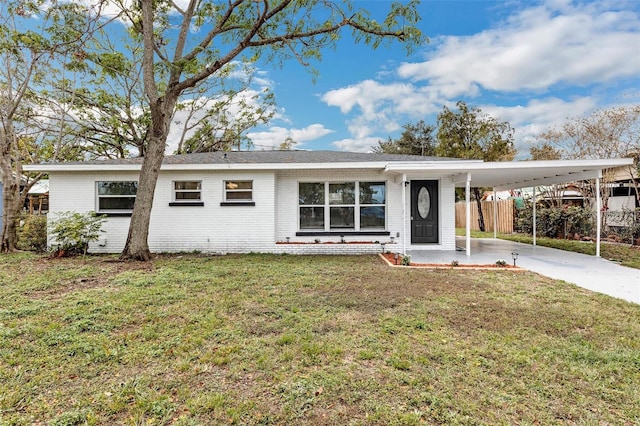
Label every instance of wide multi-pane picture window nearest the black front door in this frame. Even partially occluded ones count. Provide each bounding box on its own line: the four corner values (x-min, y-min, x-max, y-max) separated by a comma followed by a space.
298, 182, 386, 231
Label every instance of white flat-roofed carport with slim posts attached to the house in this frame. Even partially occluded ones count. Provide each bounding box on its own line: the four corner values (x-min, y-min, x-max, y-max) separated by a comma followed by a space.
385, 158, 633, 256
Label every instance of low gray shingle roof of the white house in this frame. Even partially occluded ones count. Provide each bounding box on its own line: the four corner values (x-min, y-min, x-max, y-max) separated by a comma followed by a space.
60, 150, 470, 165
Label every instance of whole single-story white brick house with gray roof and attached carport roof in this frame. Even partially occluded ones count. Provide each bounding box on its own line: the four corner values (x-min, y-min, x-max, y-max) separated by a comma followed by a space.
24, 151, 632, 254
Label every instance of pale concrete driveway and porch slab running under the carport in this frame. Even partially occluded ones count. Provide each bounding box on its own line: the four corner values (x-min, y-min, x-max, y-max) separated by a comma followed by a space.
407, 237, 640, 304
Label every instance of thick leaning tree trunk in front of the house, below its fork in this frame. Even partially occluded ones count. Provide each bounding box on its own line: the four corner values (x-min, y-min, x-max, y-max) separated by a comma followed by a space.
120, 98, 177, 262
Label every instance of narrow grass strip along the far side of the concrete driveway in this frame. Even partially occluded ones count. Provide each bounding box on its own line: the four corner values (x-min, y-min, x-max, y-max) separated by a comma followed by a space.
456, 228, 640, 269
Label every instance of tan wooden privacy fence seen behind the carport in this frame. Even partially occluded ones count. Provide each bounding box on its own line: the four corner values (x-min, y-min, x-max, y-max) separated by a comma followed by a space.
456, 199, 515, 234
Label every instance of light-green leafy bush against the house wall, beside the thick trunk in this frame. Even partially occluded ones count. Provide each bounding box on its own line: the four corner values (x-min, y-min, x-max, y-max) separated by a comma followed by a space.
49, 212, 106, 256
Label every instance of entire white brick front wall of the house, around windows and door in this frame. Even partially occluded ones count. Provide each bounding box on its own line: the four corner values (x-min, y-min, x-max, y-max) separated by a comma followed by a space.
49, 169, 455, 254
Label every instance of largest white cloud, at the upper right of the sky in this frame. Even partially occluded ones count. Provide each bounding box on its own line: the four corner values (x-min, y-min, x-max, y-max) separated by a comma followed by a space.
398, 2, 640, 97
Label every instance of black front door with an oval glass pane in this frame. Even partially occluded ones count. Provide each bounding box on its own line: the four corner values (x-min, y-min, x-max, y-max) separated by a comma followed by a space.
411, 180, 438, 244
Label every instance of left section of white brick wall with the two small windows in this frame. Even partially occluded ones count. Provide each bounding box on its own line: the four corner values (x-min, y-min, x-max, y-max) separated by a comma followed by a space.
50, 172, 275, 253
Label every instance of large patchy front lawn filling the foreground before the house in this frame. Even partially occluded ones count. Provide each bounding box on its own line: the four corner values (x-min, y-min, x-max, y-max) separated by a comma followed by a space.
0, 254, 640, 425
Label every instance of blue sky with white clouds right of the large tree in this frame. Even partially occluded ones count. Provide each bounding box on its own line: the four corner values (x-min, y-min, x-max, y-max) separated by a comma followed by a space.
239, 0, 640, 158
